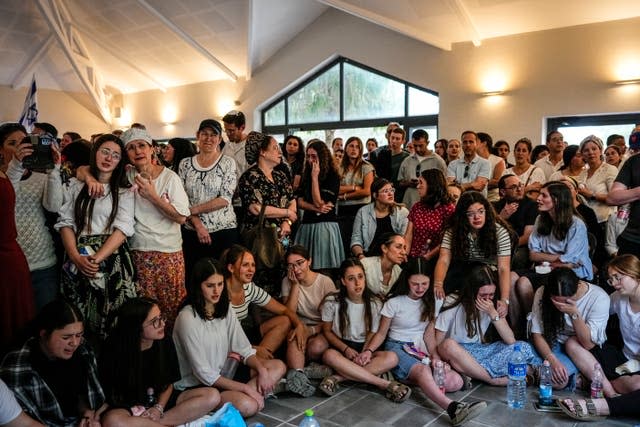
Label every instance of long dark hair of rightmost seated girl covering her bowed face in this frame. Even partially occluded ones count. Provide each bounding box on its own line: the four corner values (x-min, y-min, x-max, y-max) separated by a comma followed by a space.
540, 267, 580, 346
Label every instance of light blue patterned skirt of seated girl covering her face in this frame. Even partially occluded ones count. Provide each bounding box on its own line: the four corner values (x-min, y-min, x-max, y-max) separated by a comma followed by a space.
460, 341, 542, 378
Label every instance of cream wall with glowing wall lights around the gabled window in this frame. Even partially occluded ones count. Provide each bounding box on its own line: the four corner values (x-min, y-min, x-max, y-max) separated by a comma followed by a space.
0, 9, 640, 143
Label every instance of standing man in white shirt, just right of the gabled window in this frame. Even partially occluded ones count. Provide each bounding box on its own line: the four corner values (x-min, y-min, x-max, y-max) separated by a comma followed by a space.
447, 130, 491, 197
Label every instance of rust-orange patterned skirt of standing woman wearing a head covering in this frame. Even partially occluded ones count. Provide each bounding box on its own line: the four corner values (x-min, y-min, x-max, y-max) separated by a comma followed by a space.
132, 251, 187, 334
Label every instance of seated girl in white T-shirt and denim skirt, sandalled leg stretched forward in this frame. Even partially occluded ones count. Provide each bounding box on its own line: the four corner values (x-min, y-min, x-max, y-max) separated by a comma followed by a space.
367, 258, 487, 425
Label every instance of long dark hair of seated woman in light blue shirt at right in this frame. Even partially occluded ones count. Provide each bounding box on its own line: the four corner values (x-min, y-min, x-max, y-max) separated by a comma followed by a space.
537, 181, 579, 240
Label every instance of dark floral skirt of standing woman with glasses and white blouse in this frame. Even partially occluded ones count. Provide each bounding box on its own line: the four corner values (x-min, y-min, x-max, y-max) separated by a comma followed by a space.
60, 235, 138, 341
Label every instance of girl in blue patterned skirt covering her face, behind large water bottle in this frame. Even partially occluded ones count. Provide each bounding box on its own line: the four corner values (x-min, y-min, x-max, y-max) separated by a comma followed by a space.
436, 263, 541, 386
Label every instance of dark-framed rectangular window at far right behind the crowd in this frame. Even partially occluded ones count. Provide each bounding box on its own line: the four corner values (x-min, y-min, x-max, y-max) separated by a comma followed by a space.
547, 113, 640, 145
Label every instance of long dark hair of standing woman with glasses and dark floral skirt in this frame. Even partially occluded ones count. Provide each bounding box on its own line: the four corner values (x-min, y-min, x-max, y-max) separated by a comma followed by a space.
74, 133, 129, 234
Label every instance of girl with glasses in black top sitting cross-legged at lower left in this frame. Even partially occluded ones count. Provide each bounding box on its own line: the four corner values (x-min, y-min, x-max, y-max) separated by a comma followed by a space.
100, 298, 220, 427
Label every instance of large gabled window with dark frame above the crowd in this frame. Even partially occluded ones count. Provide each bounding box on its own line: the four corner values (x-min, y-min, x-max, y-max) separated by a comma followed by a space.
262, 58, 440, 145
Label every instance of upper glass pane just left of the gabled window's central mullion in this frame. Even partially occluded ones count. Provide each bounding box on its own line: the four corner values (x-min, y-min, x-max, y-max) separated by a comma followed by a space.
288, 64, 340, 124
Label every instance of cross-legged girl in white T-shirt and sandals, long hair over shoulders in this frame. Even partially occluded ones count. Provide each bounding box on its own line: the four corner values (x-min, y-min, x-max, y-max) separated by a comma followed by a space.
319, 258, 411, 402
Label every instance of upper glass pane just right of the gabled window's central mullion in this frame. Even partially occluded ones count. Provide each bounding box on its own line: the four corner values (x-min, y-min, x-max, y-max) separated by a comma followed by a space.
344, 64, 404, 120
